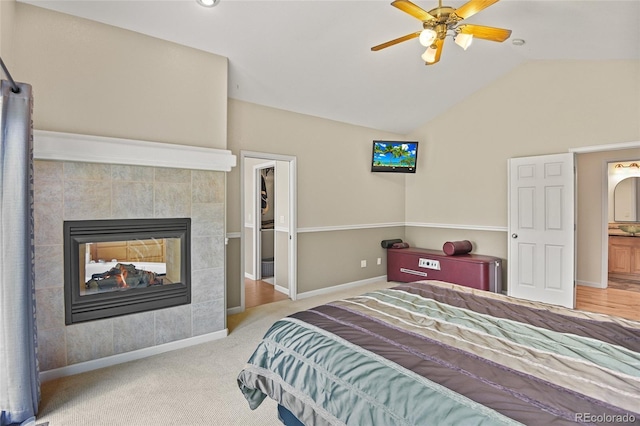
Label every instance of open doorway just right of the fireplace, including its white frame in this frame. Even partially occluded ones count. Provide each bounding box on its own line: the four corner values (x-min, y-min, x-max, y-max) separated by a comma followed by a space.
240, 151, 297, 310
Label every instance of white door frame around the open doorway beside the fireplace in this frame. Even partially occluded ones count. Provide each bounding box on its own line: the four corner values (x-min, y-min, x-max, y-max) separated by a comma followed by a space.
239, 150, 298, 312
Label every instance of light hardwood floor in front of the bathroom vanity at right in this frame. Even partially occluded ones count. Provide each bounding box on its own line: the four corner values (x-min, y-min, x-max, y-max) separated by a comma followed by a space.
576, 279, 640, 321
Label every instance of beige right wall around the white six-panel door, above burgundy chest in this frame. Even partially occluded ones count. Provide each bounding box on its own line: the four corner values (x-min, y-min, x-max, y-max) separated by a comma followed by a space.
406, 61, 640, 290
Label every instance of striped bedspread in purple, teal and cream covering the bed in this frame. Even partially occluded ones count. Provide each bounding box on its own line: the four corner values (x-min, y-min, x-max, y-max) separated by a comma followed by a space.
238, 281, 640, 426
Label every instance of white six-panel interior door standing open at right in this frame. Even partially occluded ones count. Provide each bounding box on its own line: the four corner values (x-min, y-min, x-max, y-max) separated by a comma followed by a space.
508, 153, 576, 308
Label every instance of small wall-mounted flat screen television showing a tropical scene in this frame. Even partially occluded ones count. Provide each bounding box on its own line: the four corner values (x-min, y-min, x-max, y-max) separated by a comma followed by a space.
371, 141, 418, 173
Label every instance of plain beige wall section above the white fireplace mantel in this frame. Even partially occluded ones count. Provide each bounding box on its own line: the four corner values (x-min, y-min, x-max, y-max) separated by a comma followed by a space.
11, 2, 227, 148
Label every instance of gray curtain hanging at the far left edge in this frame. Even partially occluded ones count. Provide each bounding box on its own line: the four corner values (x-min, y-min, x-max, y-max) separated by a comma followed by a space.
0, 80, 40, 426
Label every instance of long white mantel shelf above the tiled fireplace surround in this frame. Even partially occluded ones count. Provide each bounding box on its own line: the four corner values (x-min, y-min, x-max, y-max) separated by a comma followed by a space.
33, 130, 236, 172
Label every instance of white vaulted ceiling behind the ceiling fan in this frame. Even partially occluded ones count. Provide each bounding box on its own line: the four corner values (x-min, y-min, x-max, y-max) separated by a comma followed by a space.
18, 0, 640, 134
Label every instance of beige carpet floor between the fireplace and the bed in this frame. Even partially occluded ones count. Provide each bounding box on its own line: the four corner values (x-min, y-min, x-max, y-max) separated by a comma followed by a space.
37, 281, 393, 426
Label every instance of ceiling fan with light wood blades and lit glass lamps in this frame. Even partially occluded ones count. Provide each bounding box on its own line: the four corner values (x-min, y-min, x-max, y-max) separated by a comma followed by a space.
371, 0, 511, 65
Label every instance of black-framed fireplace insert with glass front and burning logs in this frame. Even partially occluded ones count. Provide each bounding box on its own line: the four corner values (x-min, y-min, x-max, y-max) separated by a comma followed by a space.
64, 218, 191, 325
